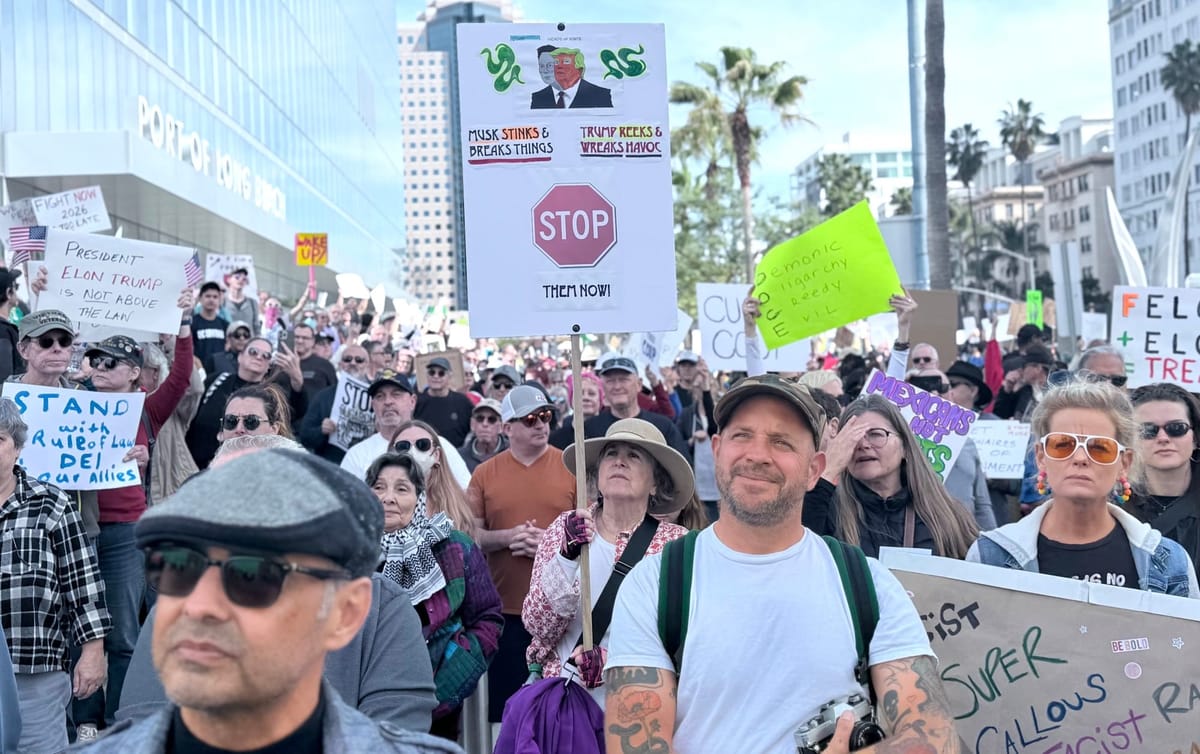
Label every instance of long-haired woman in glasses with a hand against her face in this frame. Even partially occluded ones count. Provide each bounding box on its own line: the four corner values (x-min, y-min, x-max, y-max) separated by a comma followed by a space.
838, 395, 979, 559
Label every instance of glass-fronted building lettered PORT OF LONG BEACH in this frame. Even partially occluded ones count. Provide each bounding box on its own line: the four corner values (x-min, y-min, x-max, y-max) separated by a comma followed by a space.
0, 0, 404, 295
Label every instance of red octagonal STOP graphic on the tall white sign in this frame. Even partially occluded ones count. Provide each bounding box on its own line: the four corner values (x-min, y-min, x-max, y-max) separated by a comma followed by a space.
533, 184, 617, 267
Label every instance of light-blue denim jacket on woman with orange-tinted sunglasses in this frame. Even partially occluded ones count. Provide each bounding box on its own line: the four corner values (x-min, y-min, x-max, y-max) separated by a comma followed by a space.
967, 499, 1200, 598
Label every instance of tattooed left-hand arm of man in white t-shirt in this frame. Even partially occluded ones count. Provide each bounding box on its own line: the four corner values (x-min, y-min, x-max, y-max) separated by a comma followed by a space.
604, 666, 681, 754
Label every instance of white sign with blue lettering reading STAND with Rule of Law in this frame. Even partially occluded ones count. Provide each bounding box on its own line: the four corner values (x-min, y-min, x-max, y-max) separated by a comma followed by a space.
4, 381, 144, 490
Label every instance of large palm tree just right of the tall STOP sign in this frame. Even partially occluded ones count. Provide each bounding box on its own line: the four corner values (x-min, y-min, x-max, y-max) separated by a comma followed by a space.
670, 47, 809, 281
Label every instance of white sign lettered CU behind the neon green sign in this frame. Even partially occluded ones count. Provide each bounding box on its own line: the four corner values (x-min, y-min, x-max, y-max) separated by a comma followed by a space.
696, 283, 812, 372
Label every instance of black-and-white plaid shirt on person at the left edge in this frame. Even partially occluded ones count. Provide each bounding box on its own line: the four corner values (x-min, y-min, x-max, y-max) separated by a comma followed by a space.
0, 466, 112, 674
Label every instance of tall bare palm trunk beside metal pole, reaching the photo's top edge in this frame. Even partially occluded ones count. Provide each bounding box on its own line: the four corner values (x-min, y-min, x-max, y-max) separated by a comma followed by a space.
925, 0, 950, 291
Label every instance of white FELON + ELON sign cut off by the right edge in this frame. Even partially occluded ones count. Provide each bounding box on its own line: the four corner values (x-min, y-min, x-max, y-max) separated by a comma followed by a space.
1112, 286, 1200, 393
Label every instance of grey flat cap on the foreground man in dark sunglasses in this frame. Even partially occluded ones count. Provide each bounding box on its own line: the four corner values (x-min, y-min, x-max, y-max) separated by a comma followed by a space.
134, 449, 383, 578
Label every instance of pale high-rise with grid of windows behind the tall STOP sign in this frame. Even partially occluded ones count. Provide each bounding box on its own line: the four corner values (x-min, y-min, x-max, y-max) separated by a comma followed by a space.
398, 0, 516, 309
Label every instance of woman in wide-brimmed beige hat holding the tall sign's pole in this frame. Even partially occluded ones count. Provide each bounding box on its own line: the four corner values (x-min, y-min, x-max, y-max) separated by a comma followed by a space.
521, 419, 695, 707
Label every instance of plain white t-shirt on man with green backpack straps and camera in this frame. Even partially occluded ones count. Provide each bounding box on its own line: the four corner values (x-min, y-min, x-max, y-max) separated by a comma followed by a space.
607, 527, 934, 754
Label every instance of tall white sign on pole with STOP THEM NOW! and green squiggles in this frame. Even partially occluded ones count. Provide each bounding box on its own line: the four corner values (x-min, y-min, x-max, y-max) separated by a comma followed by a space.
451, 24, 677, 337
